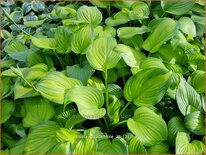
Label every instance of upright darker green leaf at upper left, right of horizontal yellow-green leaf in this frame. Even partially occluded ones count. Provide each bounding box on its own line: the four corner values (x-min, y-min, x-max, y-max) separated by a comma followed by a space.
54, 26, 72, 54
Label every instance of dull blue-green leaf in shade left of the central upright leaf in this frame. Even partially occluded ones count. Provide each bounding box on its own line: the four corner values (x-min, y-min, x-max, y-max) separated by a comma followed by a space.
67, 64, 95, 85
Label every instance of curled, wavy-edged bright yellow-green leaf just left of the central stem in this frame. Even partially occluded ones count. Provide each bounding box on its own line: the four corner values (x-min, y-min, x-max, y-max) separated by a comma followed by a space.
64, 86, 106, 119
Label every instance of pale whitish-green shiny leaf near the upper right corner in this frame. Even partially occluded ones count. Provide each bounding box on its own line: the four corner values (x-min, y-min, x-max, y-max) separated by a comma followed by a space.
178, 17, 196, 37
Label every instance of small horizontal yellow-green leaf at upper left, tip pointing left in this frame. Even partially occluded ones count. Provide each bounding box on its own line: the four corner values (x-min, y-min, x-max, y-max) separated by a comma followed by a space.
31, 36, 56, 49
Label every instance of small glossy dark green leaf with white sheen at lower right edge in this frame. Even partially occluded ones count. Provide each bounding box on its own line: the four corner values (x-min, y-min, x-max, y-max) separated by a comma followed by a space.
184, 111, 205, 135
